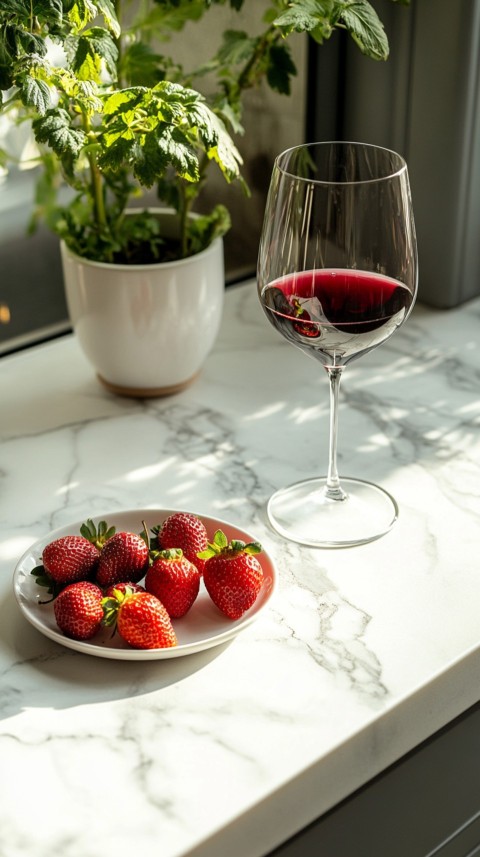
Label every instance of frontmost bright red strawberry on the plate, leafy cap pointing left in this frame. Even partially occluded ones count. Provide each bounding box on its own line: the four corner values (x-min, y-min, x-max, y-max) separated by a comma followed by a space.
102, 587, 177, 649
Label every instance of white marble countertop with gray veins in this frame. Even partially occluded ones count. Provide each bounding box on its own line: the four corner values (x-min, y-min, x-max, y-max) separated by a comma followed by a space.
0, 284, 480, 857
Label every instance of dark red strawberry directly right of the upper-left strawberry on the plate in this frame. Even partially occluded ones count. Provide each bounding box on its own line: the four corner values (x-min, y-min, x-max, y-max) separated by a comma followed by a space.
95, 532, 148, 587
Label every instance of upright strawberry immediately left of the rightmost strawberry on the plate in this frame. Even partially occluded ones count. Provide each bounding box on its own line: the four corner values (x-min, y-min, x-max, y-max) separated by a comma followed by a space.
145, 548, 200, 619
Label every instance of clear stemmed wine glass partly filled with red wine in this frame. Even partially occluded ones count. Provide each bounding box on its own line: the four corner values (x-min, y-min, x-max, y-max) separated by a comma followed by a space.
257, 137, 418, 548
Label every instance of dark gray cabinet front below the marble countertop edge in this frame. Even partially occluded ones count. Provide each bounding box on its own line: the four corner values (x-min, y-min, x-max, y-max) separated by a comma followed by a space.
268, 705, 480, 857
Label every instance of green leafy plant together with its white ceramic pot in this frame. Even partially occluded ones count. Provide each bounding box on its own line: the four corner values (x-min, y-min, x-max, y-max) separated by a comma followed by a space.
0, 0, 400, 395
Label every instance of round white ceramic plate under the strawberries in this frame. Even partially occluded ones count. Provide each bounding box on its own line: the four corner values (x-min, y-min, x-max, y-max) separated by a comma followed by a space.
13, 509, 277, 661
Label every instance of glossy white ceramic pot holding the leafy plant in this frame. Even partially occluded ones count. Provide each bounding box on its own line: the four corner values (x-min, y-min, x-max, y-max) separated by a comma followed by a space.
61, 209, 225, 397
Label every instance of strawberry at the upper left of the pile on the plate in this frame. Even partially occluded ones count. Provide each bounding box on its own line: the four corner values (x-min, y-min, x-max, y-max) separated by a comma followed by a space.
42, 536, 100, 585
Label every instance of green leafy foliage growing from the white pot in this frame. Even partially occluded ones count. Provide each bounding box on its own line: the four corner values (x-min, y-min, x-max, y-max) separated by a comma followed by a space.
0, 0, 408, 262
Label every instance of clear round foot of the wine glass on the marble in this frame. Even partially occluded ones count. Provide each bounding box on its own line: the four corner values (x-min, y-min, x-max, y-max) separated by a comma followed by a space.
267, 477, 398, 548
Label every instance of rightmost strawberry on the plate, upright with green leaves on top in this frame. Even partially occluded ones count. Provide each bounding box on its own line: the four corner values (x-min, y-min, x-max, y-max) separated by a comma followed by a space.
203, 530, 263, 619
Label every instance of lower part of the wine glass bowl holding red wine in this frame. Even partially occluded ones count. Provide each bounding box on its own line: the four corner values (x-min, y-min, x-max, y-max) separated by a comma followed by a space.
261, 268, 412, 366
